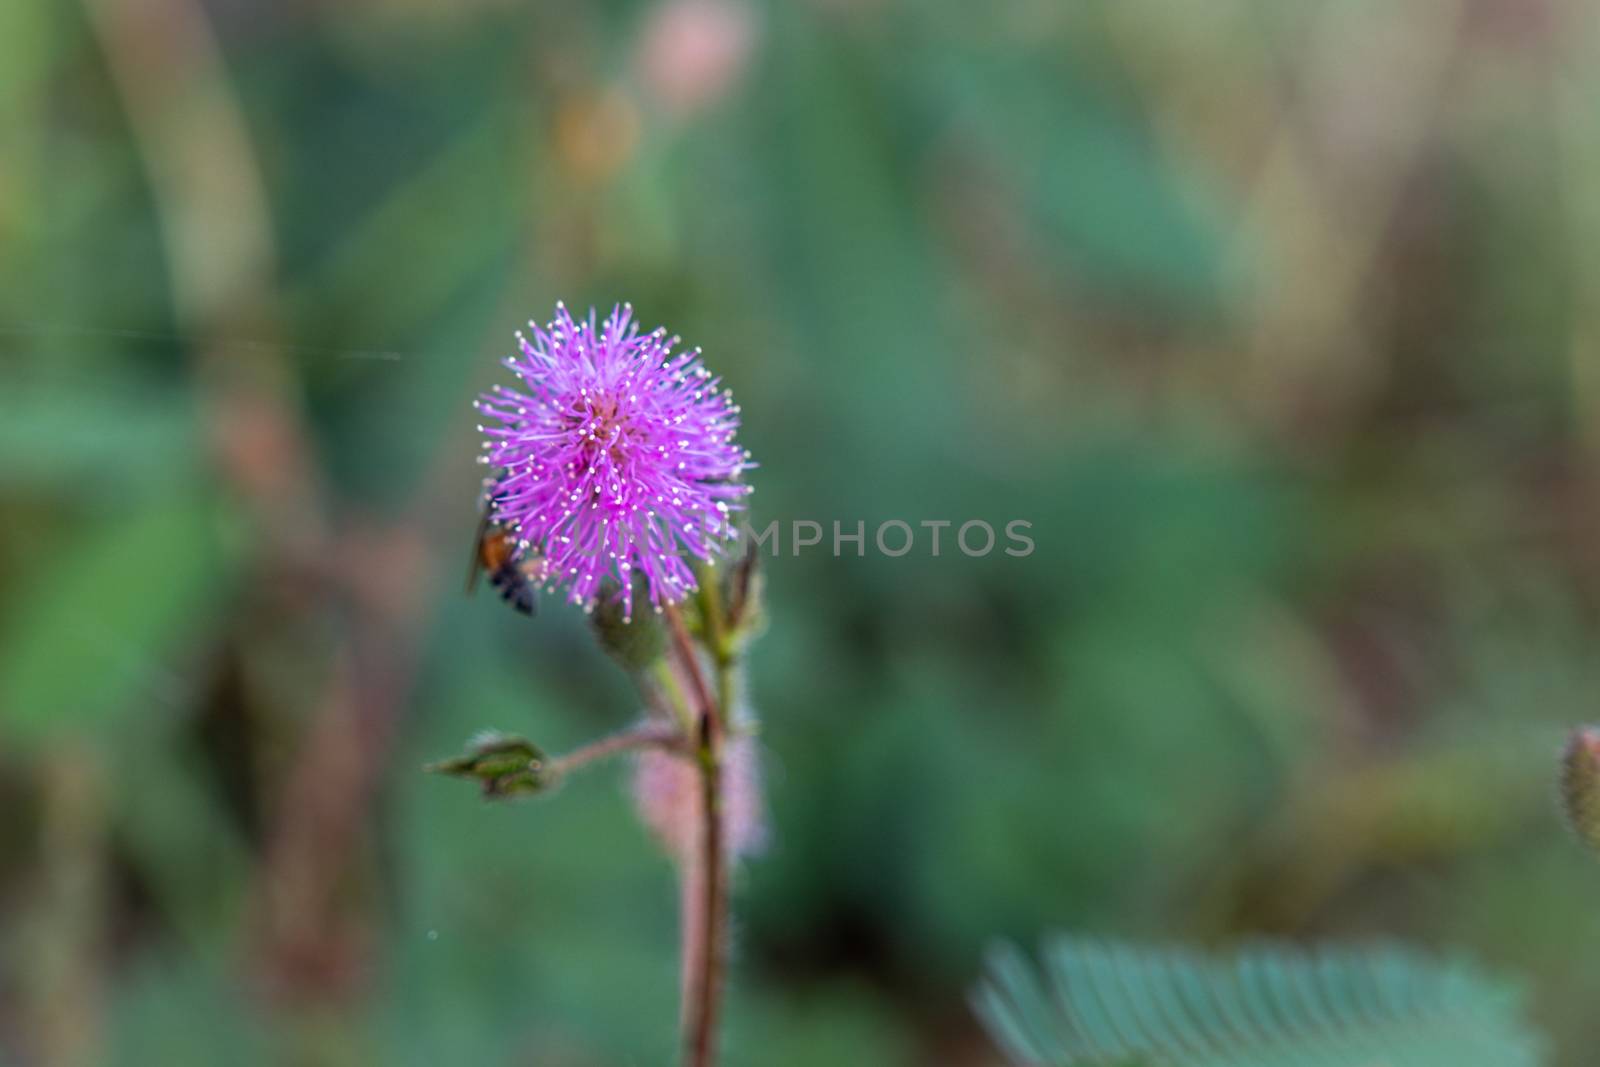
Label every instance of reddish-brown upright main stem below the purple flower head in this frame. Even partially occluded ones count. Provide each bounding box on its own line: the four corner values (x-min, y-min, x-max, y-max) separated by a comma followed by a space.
666, 605, 728, 1067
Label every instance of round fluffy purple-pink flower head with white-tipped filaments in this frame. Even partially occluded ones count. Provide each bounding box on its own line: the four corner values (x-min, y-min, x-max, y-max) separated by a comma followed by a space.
475, 304, 754, 613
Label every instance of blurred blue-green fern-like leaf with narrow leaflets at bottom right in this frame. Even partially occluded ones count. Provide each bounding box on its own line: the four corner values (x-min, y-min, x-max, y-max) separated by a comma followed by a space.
973, 937, 1541, 1067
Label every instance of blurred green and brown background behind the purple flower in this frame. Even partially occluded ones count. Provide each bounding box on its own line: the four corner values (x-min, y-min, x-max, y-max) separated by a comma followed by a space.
0, 0, 1600, 1067
